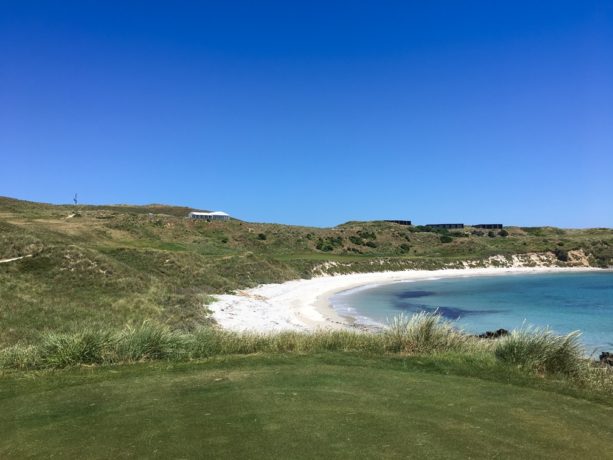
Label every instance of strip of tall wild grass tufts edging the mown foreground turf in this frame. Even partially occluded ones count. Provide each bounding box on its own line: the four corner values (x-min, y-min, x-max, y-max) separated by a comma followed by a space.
0, 313, 613, 394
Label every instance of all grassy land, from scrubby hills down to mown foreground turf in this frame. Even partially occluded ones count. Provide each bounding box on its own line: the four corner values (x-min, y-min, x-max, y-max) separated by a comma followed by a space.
0, 198, 613, 458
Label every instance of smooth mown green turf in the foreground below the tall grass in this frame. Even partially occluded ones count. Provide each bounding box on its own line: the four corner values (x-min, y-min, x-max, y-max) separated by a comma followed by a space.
0, 353, 613, 459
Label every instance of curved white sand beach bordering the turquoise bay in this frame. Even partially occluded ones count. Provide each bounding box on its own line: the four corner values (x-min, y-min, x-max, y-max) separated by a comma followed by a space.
206, 267, 603, 333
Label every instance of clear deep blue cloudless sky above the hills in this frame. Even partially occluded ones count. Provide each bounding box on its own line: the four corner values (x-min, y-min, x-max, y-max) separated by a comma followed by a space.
0, 0, 613, 227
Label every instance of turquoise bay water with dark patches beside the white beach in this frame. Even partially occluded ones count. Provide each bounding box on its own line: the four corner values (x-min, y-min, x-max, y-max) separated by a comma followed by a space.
331, 271, 613, 352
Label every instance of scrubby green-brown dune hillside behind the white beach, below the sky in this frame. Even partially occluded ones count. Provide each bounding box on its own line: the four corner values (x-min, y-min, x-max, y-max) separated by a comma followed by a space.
0, 198, 613, 346
